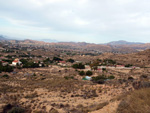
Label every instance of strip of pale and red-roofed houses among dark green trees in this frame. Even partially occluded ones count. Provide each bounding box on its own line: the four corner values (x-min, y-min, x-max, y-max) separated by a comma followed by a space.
0, 53, 140, 80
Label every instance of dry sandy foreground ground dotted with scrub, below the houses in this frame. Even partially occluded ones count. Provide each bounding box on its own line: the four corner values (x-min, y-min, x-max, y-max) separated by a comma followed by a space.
0, 66, 149, 113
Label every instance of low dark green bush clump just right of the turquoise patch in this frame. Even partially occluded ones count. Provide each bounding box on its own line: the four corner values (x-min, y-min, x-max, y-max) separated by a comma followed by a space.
92, 75, 115, 84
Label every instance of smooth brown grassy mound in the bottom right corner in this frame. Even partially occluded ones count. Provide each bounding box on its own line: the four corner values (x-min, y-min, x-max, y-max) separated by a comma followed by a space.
117, 88, 150, 113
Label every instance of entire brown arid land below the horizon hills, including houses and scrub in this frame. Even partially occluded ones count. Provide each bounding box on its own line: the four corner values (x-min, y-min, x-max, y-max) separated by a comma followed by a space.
0, 40, 150, 113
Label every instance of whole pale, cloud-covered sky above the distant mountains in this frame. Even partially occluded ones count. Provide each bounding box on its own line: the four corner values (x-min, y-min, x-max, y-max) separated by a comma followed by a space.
0, 0, 150, 43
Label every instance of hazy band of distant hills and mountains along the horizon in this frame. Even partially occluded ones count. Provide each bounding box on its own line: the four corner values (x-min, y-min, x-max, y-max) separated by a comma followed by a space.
0, 35, 150, 53
